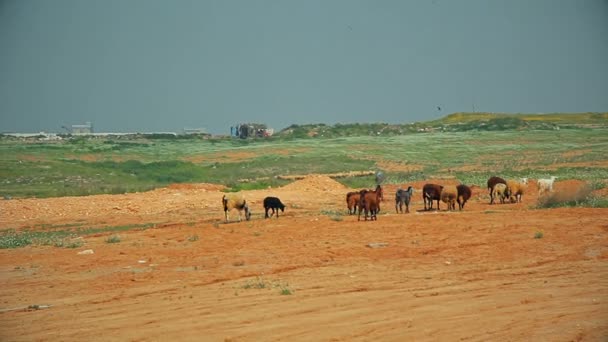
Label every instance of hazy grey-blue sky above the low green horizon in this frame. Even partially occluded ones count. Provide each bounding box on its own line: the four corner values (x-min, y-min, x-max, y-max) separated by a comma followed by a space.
0, 0, 608, 133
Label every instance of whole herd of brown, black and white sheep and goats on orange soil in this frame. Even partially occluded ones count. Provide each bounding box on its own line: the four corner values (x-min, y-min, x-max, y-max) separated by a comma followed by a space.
222, 176, 557, 222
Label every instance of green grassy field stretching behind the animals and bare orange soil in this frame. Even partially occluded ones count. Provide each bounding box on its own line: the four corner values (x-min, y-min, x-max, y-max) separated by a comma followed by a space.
0, 129, 608, 198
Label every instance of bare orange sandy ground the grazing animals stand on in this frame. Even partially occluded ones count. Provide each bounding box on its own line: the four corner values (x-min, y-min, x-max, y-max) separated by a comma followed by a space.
0, 176, 608, 341
